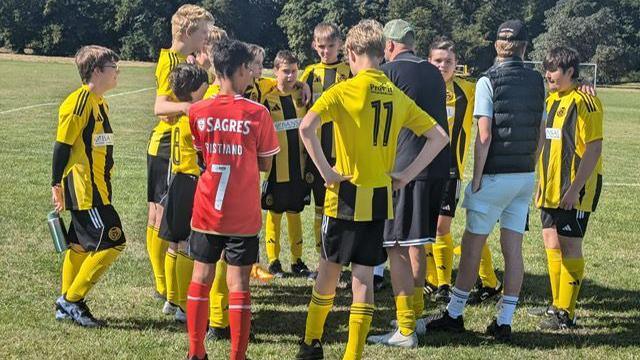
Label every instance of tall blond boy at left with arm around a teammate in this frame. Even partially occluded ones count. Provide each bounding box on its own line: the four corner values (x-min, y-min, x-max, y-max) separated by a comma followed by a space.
147, 4, 213, 308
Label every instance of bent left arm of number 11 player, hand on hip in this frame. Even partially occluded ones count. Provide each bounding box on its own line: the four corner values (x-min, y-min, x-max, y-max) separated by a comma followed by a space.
300, 110, 351, 187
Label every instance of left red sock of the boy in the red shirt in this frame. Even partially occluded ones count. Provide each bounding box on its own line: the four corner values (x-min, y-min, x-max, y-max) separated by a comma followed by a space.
187, 281, 210, 359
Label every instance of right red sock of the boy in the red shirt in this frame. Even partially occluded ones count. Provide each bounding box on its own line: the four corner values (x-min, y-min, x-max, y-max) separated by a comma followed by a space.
229, 291, 251, 360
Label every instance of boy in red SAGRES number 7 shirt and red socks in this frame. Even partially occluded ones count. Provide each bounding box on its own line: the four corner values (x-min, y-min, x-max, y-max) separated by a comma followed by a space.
182, 40, 280, 360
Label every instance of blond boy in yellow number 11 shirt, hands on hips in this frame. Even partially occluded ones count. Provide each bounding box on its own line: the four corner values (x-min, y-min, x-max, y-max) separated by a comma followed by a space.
296, 20, 448, 360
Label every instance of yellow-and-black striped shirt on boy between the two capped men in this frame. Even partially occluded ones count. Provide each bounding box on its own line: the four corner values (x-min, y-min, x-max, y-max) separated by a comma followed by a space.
447, 77, 476, 179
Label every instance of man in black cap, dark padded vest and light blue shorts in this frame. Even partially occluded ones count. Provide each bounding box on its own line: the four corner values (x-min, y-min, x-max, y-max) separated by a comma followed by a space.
426, 20, 545, 340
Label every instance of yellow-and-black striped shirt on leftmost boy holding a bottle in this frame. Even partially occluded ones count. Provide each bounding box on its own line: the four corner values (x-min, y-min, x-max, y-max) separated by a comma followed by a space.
56, 85, 113, 210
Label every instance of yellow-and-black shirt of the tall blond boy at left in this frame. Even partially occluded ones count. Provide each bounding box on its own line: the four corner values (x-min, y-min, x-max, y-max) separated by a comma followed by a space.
147, 49, 187, 159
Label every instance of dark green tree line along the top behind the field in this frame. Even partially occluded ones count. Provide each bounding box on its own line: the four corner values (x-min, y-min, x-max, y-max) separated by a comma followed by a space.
0, 0, 640, 82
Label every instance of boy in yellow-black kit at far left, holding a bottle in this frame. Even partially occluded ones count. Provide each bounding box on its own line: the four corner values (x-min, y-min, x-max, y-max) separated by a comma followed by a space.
51, 45, 125, 327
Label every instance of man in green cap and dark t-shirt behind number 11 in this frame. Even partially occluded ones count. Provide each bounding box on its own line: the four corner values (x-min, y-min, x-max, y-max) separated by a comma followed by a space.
367, 19, 451, 347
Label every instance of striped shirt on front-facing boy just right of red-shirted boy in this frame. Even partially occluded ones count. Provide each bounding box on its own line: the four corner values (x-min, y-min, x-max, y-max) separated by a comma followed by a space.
263, 87, 307, 183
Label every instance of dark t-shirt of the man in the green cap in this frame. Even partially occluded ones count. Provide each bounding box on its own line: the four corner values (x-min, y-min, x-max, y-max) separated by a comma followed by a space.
382, 51, 451, 180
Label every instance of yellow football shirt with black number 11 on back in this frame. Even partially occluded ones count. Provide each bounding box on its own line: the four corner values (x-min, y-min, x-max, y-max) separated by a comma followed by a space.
310, 69, 437, 221
